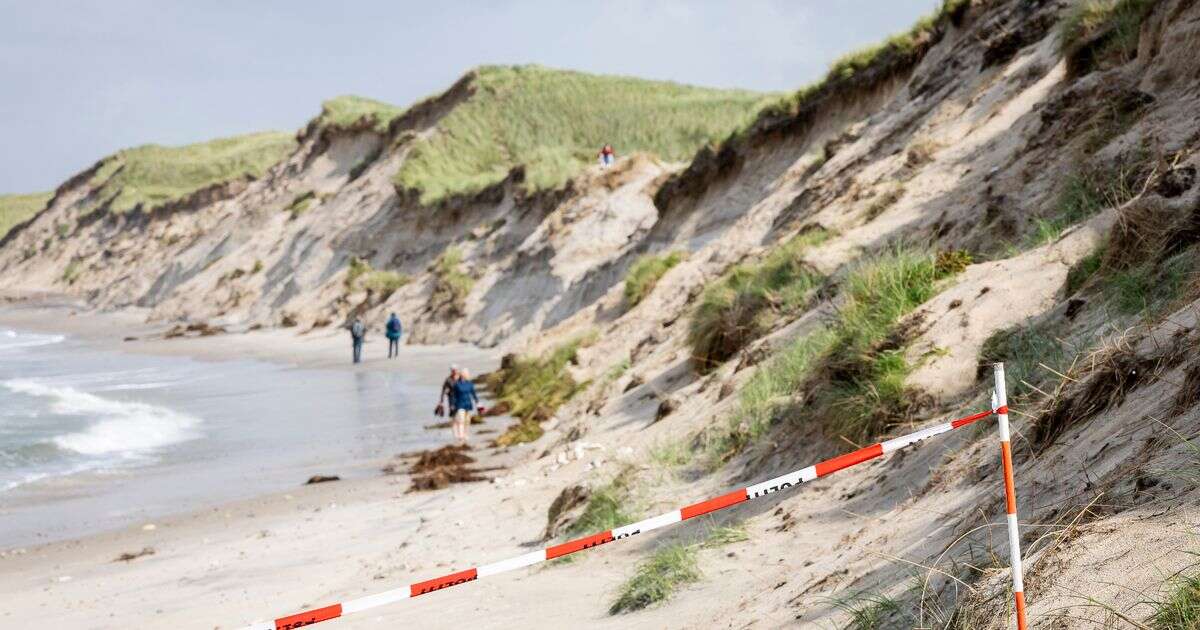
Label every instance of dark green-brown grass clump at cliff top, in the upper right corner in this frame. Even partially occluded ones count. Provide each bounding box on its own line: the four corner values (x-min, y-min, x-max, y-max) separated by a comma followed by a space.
1058, 0, 1157, 74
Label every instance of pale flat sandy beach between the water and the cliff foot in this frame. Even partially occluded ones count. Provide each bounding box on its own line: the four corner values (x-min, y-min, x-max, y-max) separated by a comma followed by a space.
0, 306, 816, 629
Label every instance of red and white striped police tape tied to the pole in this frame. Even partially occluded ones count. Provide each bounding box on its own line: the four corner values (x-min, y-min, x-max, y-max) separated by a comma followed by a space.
244, 404, 998, 630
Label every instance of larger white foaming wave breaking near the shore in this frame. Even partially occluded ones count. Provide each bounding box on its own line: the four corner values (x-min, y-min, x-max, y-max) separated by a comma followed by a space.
0, 379, 200, 457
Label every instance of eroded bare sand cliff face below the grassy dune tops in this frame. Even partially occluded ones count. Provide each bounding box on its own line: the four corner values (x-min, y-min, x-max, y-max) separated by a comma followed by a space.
0, 0, 1200, 628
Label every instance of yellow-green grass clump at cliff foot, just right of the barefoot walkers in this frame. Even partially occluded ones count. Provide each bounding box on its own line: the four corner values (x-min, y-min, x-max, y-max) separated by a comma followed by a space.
487, 338, 587, 446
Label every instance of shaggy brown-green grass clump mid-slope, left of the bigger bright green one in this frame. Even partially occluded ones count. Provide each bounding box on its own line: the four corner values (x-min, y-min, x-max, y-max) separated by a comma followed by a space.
688, 229, 829, 373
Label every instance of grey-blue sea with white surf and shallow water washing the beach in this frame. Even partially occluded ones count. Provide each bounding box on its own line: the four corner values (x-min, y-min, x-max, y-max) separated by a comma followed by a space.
0, 325, 460, 550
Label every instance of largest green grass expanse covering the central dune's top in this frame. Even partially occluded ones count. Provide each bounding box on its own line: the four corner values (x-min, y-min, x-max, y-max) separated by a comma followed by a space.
394, 66, 763, 204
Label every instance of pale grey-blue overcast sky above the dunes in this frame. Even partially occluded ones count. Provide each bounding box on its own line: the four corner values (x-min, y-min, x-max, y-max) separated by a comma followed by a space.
0, 0, 938, 193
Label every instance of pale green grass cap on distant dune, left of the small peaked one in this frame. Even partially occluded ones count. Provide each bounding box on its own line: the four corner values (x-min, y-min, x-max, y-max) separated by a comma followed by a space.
92, 132, 296, 214
